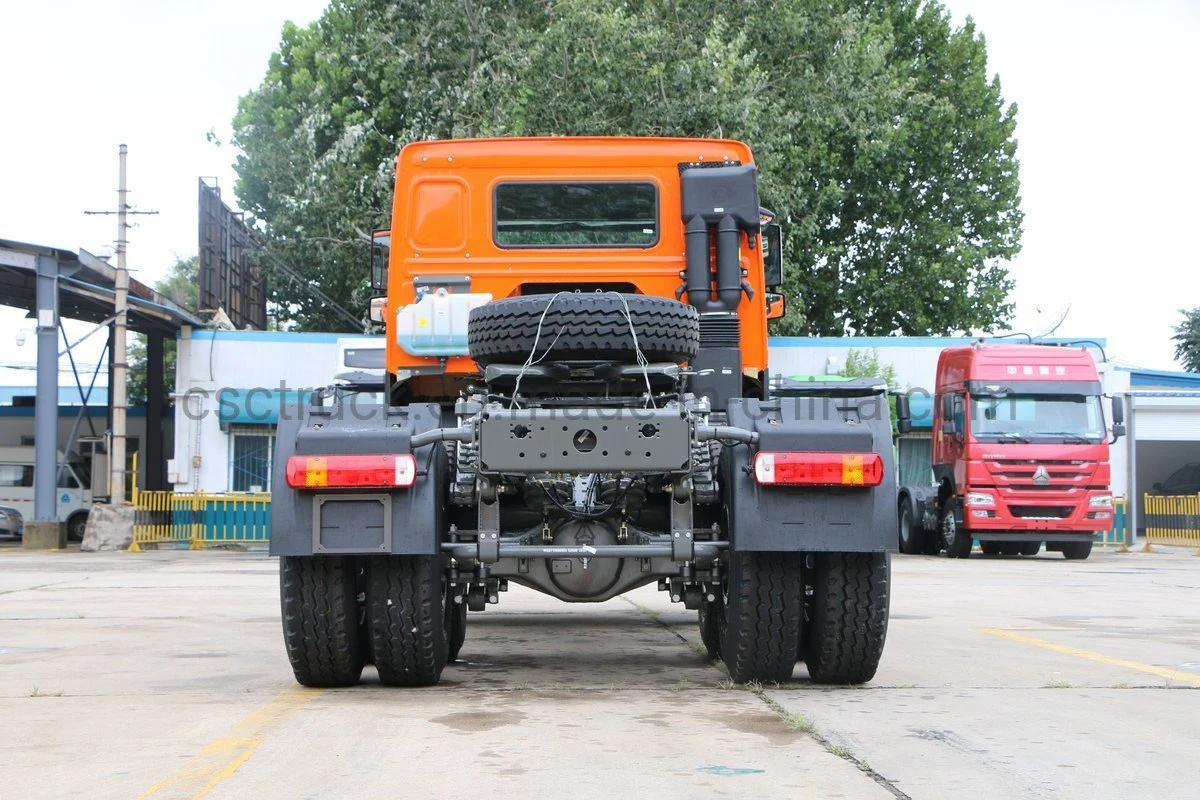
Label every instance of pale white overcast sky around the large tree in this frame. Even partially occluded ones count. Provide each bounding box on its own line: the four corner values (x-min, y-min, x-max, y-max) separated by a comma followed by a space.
0, 0, 1200, 384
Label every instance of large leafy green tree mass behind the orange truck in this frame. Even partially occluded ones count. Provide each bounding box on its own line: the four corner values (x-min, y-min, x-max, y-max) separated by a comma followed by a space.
234, 0, 1021, 336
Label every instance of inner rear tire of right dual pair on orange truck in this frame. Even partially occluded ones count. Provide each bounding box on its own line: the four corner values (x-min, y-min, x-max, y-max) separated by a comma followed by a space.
719, 551, 804, 684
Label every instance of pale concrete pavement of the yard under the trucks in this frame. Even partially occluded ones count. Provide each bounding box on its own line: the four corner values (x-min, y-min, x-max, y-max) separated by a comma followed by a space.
0, 548, 1200, 798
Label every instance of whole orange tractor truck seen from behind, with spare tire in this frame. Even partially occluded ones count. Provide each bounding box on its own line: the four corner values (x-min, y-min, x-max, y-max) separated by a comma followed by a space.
271, 138, 896, 686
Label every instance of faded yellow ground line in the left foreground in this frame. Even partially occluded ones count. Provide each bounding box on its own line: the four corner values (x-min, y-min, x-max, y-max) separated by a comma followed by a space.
138, 686, 322, 800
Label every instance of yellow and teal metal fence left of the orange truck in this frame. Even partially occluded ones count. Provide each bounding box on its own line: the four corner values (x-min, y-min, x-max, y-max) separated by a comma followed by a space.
130, 492, 271, 552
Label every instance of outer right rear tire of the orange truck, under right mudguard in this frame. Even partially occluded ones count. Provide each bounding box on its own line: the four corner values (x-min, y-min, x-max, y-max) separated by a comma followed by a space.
803, 553, 892, 684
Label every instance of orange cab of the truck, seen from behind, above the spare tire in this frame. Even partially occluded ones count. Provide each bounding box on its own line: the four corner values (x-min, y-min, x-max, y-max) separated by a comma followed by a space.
373, 137, 784, 399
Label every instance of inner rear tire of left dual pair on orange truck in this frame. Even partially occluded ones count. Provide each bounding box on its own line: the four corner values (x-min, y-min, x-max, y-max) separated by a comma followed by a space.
367, 555, 449, 686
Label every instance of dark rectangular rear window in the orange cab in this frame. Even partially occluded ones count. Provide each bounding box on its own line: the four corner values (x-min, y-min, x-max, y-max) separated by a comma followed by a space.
494, 181, 659, 247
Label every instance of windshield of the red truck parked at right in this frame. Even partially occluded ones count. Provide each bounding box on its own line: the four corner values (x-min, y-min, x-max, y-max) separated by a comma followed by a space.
971, 395, 1104, 444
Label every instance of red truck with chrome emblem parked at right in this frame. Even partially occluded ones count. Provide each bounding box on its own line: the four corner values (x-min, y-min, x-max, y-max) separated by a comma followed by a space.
898, 343, 1124, 559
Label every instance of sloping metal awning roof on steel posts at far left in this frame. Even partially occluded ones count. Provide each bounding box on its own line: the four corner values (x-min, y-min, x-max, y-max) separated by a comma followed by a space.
0, 239, 204, 336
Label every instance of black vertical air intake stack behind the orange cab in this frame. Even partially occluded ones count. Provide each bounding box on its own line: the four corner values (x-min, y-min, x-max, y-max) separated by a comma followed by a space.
679, 163, 760, 411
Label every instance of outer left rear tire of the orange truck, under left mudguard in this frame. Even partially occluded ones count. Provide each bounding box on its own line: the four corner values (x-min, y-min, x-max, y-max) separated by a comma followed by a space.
280, 555, 365, 688
